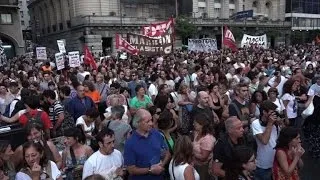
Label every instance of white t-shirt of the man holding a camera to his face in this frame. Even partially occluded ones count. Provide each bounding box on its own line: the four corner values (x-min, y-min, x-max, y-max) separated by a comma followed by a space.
251, 119, 280, 169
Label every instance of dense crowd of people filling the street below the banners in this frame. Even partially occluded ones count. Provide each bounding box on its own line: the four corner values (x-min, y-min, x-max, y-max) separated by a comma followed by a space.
0, 45, 320, 180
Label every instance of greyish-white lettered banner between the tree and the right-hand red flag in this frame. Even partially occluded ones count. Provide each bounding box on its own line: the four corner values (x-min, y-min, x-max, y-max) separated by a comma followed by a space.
188, 38, 218, 53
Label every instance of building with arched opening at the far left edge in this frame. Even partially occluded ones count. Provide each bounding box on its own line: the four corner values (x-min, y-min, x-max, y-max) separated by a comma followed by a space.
0, 0, 24, 58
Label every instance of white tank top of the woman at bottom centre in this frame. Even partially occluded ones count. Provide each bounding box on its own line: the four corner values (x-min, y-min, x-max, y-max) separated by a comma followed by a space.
169, 160, 200, 180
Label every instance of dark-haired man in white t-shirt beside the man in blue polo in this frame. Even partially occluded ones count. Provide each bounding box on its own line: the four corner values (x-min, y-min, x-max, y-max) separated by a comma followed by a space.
82, 128, 124, 179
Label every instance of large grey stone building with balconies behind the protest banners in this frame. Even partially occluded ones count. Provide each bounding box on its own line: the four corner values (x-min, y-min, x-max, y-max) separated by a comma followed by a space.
28, 0, 290, 53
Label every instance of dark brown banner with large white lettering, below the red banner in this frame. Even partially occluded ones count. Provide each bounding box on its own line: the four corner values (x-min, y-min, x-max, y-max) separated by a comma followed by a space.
127, 32, 173, 55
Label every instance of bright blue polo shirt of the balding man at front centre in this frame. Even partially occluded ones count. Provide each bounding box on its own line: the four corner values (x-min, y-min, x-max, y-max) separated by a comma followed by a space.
124, 129, 168, 180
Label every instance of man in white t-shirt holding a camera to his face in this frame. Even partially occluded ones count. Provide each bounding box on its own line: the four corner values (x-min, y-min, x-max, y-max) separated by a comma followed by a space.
251, 100, 280, 180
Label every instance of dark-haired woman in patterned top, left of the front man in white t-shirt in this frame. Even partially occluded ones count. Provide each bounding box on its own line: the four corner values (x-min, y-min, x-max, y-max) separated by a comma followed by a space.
62, 126, 93, 179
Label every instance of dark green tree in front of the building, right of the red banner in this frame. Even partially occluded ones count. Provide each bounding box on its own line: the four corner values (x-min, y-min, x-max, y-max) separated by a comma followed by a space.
175, 16, 197, 44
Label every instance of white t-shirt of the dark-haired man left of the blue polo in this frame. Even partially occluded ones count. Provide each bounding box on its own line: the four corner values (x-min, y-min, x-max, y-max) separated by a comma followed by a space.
82, 149, 123, 179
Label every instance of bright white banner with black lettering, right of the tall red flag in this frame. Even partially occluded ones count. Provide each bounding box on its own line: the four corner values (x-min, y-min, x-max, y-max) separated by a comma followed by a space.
241, 34, 268, 49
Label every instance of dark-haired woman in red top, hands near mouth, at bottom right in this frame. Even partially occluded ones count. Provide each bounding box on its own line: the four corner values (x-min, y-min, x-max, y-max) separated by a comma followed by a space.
272, 127, 305, 180
